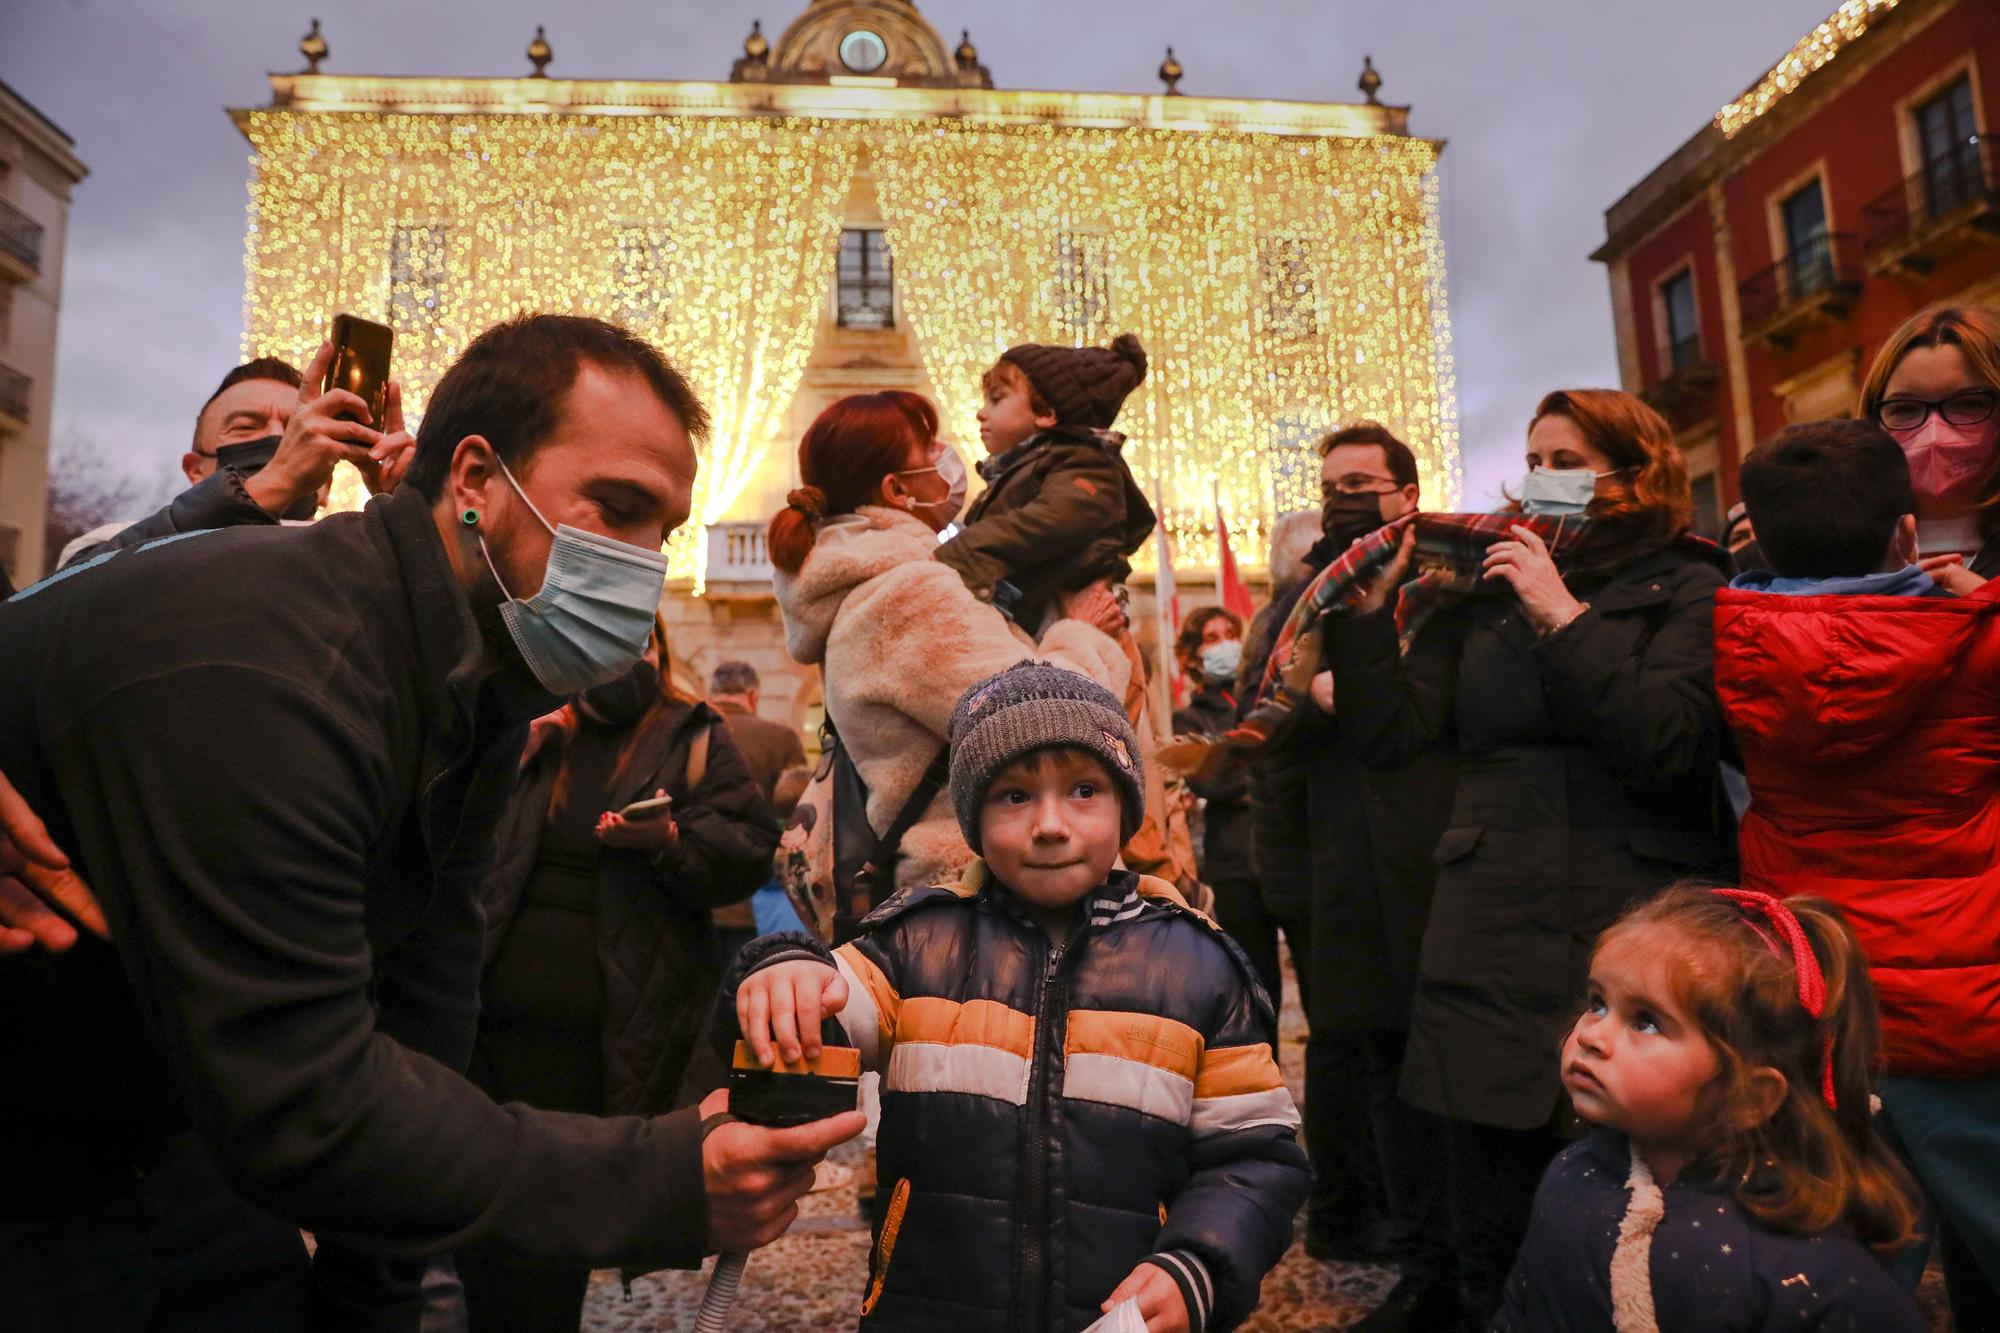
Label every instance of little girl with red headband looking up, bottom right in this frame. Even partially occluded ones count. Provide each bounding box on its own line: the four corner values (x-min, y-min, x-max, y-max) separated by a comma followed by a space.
1494, 887, 1926, 1333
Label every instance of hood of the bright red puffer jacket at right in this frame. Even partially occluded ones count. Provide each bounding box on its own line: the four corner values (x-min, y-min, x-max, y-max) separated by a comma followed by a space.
1716, 588, 2000, 761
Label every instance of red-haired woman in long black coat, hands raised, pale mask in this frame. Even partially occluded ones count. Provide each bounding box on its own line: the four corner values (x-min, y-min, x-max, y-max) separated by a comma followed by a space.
1326, 388, 1734, 1327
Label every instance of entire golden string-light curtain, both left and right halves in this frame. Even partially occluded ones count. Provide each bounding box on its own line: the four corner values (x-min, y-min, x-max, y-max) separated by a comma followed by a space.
244, 110, 1460, 582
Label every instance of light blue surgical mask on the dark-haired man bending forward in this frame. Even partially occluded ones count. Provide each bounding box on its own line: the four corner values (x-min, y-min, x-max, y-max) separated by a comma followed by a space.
480, 462, 666, 695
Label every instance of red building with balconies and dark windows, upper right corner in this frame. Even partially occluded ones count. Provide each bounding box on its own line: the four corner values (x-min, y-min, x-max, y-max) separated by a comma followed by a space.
1592, 0, 2000, 532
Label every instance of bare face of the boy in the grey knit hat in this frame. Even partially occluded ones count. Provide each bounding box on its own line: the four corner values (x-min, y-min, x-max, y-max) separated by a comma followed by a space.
980, 749, 1122, 917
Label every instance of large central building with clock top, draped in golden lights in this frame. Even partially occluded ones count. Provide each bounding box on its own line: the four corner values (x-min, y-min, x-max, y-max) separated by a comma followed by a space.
232, 0, 1460, 715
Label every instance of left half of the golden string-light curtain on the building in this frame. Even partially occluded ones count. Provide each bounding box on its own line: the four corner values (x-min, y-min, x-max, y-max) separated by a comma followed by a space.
244, 112, 856, 580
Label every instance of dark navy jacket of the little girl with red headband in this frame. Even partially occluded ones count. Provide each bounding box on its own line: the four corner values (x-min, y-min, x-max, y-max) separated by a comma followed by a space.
1492, 1129, 1930, 1333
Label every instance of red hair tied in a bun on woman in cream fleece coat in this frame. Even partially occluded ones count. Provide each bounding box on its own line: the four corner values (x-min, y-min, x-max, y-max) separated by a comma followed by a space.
764, 388, 938, 574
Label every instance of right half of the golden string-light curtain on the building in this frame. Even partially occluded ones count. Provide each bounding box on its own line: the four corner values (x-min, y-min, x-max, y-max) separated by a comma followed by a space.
872, 122, 1460, 566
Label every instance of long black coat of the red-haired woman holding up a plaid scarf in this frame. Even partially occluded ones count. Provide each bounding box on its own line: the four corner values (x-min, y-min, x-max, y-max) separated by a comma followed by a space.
1326, 538, 1734, 1129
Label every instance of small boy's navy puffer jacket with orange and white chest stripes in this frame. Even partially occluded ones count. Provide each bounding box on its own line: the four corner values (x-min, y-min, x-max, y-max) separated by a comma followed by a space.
718, 861, 1312, 1333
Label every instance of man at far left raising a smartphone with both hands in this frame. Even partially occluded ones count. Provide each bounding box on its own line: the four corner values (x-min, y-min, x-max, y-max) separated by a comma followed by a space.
56, 342, 416, 568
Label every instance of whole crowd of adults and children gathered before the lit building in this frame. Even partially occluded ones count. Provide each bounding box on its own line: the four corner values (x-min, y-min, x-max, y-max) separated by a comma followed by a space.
0, 306, 2000, 1333
